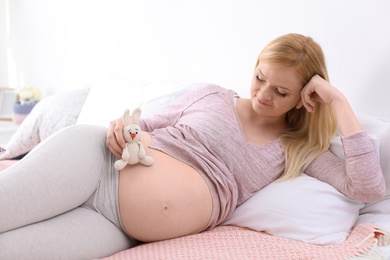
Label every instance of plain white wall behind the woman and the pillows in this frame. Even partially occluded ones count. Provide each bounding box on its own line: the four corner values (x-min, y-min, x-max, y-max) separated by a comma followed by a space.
0, 0, 390, 119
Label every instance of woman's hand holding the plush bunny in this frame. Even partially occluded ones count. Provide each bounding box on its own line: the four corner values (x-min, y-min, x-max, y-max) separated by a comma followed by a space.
106, 118, 126, 158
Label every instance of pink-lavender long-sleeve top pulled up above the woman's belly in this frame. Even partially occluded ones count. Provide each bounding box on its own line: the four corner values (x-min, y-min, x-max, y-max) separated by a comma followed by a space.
140, 85, 385, 230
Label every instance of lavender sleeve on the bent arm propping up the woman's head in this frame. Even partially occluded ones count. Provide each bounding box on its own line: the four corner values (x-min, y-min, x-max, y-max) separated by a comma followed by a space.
305, 131, 386, 202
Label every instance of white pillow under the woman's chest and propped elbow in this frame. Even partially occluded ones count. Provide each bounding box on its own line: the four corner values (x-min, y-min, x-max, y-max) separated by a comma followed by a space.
224, 174, 364, 245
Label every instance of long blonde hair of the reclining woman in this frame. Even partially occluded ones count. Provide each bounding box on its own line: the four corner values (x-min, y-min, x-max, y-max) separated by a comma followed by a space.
257, 34, 337, 180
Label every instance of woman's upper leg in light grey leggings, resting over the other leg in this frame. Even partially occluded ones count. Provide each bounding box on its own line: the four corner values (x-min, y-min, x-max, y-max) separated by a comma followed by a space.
0, 126, 107, 233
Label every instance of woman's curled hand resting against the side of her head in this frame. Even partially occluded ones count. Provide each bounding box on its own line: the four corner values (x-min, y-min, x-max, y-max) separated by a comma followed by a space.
297, 75, 345, 112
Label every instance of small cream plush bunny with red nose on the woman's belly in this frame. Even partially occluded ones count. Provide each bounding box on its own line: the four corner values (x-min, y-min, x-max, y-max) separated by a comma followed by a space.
114, 108, 153, 171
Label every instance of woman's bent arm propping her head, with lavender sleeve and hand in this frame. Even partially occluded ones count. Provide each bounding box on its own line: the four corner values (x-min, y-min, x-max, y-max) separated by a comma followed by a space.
301, 75, 386, 202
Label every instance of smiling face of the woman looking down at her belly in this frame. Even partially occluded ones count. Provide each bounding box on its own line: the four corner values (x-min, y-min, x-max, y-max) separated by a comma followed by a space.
250, 62, 303, 117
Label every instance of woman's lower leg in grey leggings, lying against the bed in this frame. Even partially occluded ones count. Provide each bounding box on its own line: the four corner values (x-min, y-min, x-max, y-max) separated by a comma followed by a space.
0, 208, 134, 260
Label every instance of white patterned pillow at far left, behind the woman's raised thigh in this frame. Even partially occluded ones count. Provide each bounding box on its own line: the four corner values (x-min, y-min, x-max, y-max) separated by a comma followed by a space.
0, 88, 89, 160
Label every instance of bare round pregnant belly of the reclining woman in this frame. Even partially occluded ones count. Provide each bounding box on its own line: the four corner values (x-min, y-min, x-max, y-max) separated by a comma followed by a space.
119, 133, 212, 242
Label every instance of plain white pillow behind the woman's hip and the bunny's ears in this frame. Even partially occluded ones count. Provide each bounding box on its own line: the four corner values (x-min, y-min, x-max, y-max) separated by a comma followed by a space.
76, 74, 201, 127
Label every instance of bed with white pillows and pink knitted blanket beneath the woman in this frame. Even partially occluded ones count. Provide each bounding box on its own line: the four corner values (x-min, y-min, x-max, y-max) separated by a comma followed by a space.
0, 74, 390, 260
